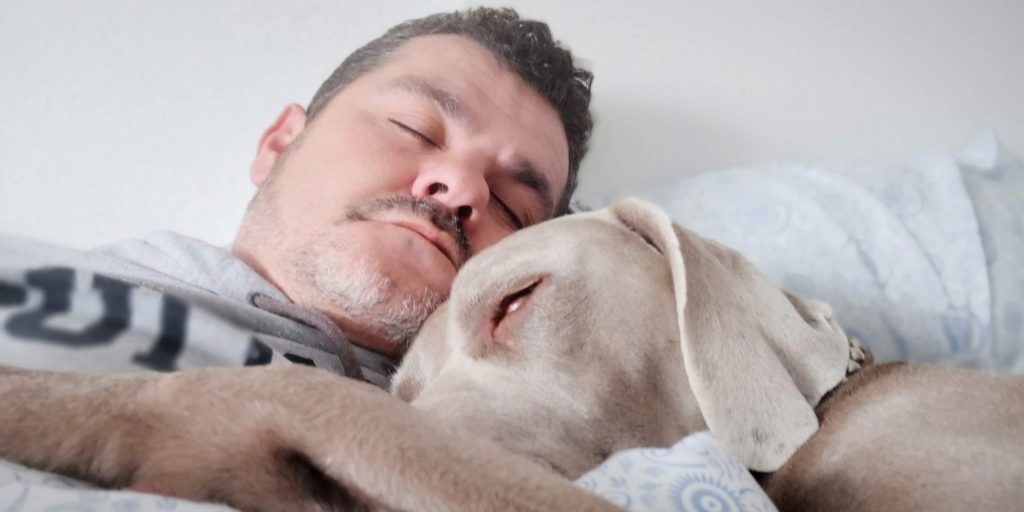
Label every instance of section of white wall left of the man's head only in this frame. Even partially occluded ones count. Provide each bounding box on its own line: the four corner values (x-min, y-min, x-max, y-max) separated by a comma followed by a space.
0, 0, 463, 247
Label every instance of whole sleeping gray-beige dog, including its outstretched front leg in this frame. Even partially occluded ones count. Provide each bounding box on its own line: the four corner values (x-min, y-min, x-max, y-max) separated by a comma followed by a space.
0, 200, 1024, 510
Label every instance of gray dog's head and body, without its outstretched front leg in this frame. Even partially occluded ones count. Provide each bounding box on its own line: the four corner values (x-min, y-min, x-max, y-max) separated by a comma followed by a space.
393, 200, 1024, 511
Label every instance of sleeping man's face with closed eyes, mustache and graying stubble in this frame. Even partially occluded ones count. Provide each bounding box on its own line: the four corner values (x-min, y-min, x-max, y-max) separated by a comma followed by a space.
234, 35, 568, 353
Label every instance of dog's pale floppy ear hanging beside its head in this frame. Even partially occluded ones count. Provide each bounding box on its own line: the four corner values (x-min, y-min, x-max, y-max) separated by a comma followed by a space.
610, 199, 850, 471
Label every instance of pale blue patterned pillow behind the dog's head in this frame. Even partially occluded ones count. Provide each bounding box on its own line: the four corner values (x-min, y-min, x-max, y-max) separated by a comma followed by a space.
647, 134, 1024, 373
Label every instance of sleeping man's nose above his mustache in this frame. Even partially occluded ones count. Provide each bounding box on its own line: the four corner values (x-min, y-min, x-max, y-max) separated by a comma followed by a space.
413, 161, 490, 224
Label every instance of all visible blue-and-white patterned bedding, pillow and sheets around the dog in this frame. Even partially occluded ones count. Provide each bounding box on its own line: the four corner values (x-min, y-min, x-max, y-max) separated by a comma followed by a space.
0, 132, 1024, 512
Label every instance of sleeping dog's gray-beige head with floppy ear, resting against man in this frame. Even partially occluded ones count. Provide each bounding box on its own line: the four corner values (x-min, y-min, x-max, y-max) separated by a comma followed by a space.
393, 200, 849, 477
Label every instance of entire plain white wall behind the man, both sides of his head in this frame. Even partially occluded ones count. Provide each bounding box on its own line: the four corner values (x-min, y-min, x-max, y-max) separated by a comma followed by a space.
0, 0, 1024, 247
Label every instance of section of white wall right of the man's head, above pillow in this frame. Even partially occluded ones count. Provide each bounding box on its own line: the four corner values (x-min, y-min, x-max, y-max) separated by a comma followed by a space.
489, 0, 1024, 203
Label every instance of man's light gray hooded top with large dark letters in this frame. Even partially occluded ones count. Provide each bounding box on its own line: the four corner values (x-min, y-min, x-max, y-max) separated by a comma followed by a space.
0, 231, 395, 387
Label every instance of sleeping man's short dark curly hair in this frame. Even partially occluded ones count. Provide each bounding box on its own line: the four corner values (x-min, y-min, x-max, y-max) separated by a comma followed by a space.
307, 7, 594, 215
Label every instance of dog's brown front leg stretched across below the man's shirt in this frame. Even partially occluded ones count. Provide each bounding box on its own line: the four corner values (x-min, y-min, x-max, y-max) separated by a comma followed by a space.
0, 365, 620, 512
